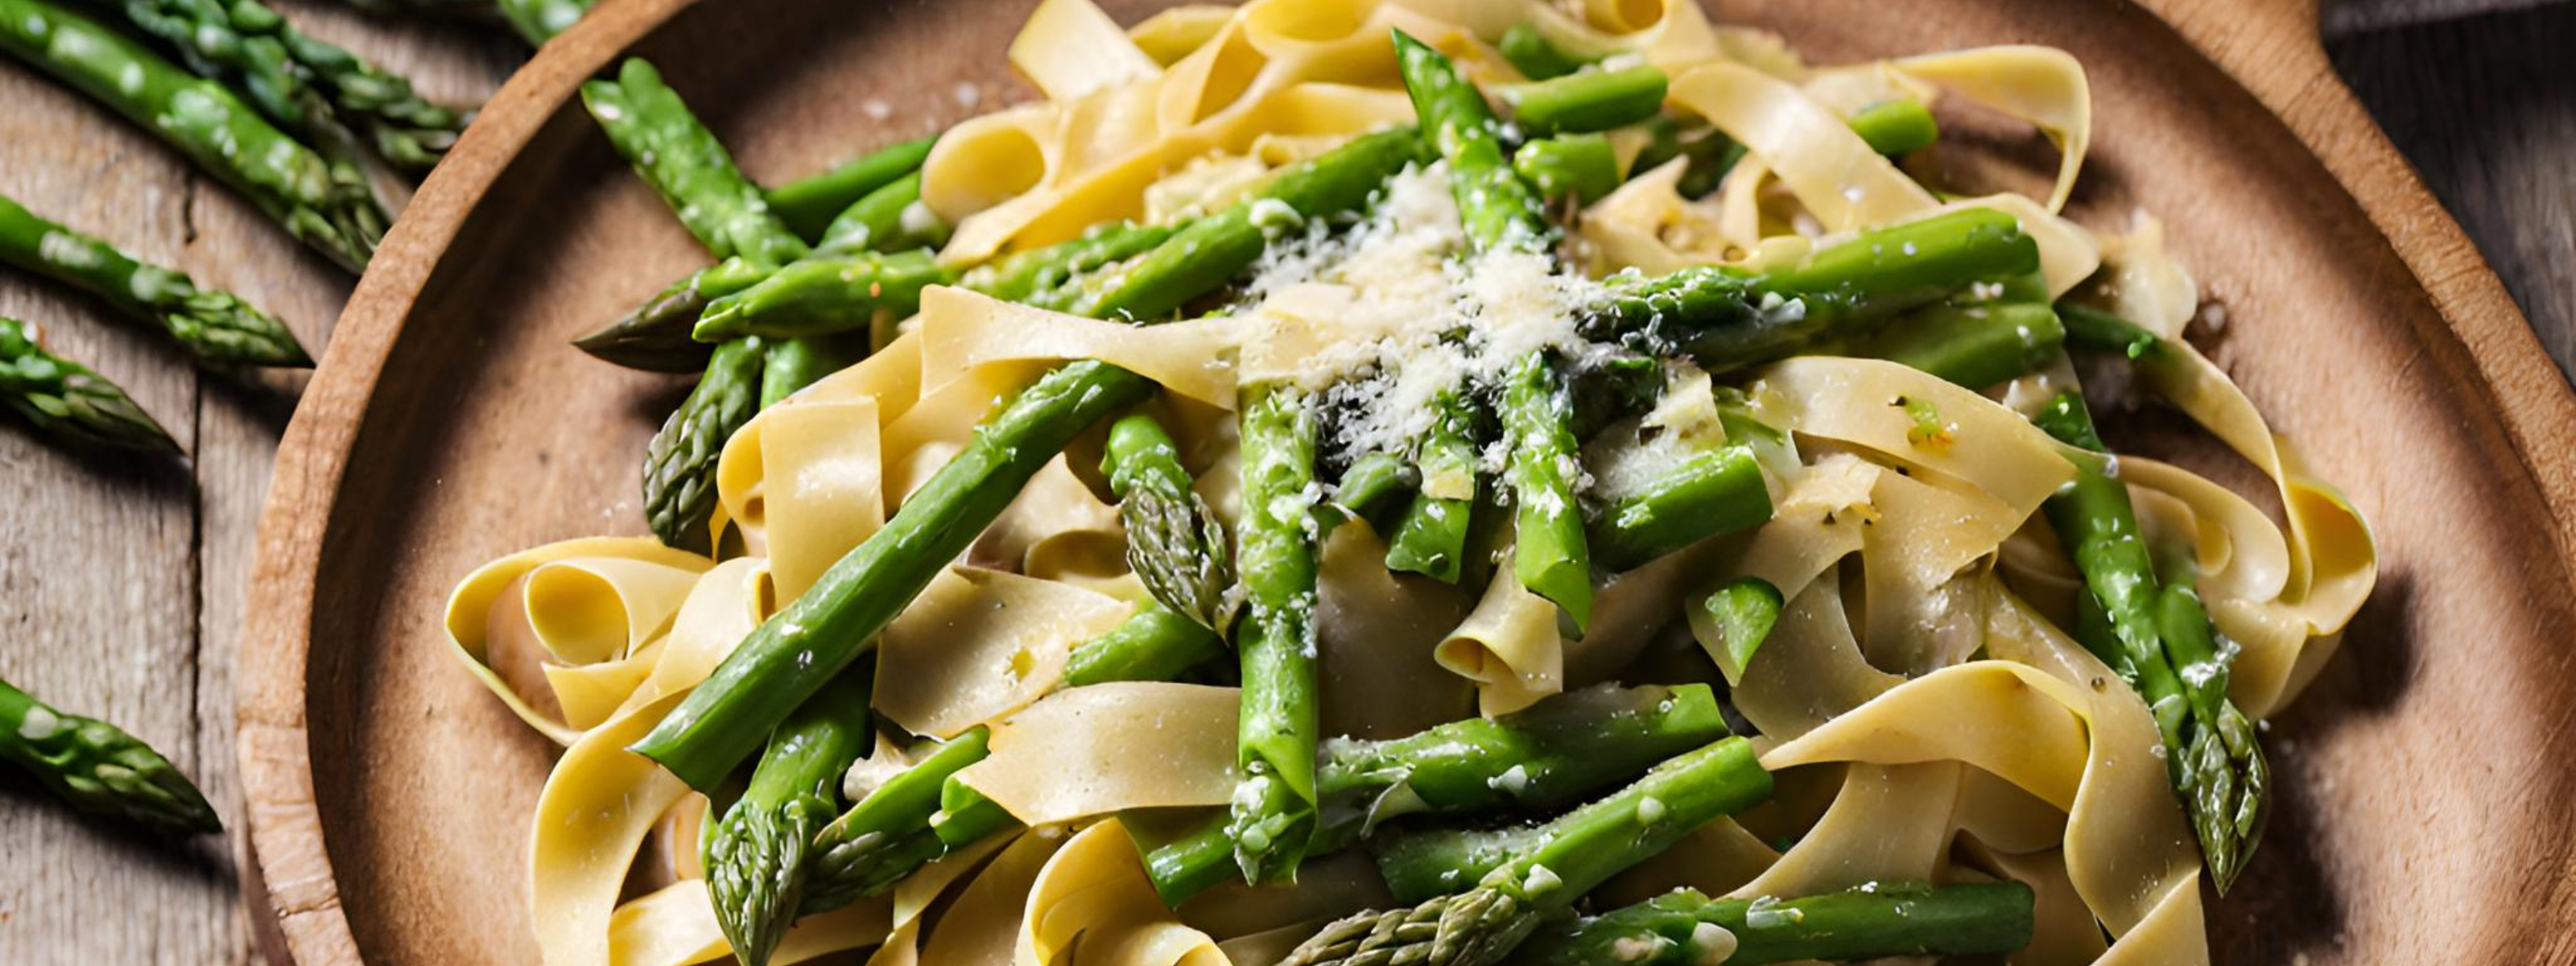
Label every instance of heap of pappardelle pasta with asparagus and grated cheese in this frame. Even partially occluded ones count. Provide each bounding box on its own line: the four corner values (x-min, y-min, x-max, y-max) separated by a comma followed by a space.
446, 0, 2375, 966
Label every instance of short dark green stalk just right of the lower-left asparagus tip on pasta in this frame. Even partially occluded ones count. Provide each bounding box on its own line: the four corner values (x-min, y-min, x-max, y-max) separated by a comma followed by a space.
803, 726, 992, 914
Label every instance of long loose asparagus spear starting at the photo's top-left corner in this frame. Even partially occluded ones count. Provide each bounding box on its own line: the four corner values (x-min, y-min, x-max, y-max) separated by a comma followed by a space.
0, 0, 386, 270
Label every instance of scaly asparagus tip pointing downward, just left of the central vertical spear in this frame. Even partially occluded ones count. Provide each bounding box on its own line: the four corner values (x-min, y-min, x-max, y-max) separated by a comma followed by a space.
1100, 412, 1234, 631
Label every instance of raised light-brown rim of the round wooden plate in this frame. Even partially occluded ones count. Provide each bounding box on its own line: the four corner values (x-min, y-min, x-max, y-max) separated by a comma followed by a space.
237, 0, 2576, 966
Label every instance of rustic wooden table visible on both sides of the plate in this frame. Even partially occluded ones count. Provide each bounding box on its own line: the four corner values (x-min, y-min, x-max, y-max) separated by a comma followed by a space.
0, 0, 2576, 966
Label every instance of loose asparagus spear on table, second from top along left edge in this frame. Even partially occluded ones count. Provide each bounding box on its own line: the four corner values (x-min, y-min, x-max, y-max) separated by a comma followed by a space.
0, 198, 314, 365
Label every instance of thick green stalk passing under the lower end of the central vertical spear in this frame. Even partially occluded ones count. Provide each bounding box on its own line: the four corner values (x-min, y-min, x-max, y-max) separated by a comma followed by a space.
1146, 685, 1726, 906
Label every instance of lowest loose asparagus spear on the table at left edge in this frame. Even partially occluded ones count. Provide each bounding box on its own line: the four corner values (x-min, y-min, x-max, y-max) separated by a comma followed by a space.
0, 675, 224, 835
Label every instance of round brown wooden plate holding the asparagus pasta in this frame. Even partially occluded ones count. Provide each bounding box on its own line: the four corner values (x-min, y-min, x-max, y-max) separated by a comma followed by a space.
240, 0, 2576, 966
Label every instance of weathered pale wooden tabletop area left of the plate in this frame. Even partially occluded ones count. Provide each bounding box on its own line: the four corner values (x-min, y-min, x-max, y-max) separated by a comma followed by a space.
0, 0, 523, 966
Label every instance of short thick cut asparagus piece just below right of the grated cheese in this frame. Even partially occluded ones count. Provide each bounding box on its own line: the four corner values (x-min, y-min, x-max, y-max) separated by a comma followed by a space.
1587, 446, 1773, 575
